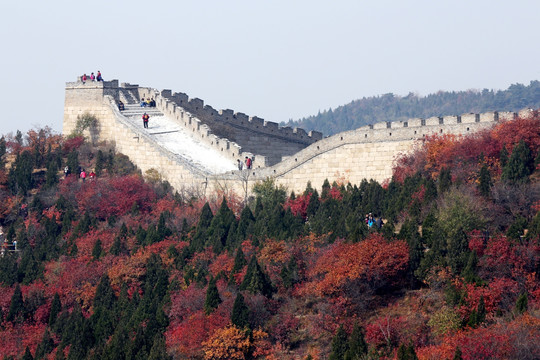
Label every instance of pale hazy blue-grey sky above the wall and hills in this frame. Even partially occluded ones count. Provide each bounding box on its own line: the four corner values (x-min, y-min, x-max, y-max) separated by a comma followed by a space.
0, 0, 540, 134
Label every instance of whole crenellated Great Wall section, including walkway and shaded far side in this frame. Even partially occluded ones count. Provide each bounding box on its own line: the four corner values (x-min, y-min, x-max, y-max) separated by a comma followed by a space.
63, 79, 528, 195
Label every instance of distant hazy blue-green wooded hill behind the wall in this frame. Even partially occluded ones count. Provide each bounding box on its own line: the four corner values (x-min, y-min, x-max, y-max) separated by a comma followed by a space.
286, 80, 540, 135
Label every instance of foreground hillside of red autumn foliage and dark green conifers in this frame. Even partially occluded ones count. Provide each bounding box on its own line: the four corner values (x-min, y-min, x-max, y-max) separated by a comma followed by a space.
0, 114, 540, 360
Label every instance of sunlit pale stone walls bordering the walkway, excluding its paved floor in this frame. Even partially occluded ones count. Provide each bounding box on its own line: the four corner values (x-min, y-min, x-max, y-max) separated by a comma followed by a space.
63, 80, 527, 195
